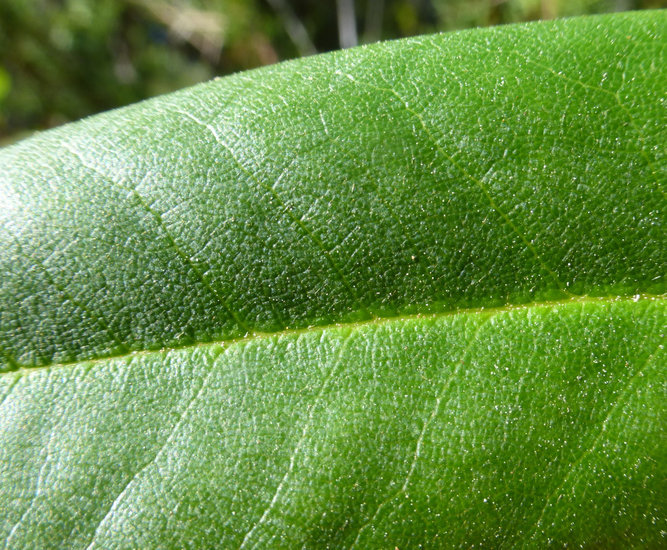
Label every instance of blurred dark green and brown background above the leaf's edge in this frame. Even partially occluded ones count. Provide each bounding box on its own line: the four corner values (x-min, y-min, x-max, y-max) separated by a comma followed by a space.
0, 0, 665, 145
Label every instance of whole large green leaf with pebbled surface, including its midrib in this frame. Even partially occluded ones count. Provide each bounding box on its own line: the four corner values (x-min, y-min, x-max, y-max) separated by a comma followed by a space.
0, 11, 667, 548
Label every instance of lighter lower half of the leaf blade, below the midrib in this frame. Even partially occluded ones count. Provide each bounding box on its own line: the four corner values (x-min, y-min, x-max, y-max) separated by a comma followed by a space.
0, 300, 665, 547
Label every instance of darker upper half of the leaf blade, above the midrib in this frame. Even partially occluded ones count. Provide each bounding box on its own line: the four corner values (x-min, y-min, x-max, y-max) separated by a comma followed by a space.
0, 12, 665, 369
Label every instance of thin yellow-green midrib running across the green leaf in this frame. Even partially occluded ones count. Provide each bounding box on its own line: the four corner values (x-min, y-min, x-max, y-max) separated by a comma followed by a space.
5, 294, 667, 376
